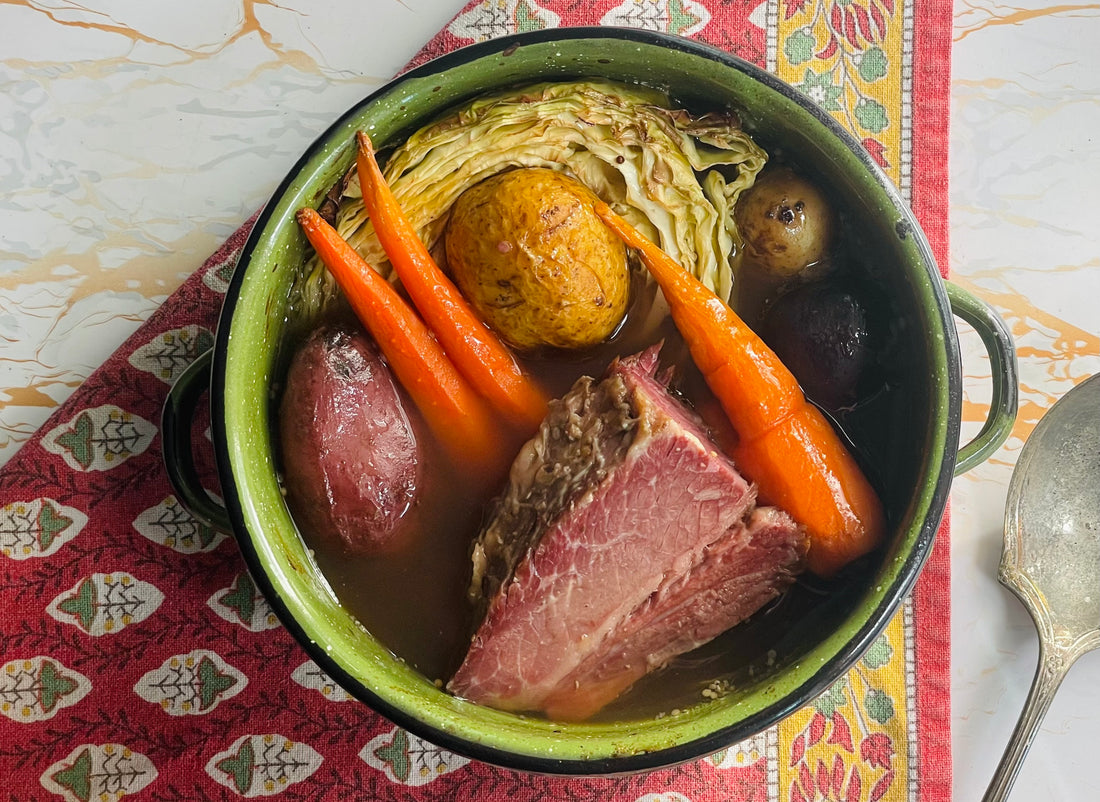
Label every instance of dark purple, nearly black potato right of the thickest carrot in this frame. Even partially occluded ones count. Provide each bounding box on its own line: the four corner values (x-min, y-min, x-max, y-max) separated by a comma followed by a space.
760, 283, 871, 410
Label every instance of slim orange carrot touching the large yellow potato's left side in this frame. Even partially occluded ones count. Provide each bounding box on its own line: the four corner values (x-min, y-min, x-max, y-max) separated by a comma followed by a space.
356, 131, 548, 433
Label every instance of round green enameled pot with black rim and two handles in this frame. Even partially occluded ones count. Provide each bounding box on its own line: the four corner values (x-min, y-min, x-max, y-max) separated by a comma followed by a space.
164, 29, 1016, 774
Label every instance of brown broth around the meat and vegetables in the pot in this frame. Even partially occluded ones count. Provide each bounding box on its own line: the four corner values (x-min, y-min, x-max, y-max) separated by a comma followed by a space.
281, 203, 912, 721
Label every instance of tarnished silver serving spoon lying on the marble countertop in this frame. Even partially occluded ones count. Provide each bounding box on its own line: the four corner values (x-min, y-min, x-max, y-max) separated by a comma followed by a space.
983, 374, 1100, 802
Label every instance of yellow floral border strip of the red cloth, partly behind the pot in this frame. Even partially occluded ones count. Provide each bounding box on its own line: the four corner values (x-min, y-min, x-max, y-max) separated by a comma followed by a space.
767, 0, 916, 802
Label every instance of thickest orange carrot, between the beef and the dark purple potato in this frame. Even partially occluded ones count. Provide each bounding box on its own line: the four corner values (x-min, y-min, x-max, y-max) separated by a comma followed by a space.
595, 202, 886, 576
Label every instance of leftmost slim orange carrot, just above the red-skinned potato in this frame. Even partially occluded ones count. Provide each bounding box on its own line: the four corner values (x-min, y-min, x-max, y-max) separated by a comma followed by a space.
297, 209, 506, 481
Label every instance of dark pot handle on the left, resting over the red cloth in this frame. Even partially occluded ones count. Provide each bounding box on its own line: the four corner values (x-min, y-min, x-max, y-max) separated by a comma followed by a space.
161, 349, 232, 534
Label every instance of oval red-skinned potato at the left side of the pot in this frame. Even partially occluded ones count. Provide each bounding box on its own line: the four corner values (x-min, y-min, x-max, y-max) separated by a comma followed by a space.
279, 328, 424, 554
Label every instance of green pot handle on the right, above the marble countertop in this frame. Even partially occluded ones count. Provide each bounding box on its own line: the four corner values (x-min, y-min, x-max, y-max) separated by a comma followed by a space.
945, 282, 1019, 476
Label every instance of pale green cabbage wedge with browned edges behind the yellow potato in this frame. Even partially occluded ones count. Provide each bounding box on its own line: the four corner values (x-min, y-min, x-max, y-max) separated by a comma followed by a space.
305, 80, 768, 316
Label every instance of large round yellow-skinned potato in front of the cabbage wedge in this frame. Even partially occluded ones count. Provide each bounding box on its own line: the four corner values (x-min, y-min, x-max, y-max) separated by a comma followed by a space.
437, 167, 630, 351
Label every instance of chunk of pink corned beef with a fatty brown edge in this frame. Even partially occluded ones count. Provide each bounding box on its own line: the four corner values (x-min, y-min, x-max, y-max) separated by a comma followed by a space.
449, 348, 806, 718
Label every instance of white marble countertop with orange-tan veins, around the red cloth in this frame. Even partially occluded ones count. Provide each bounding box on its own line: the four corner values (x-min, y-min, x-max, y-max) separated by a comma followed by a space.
0, 0, 1100, 801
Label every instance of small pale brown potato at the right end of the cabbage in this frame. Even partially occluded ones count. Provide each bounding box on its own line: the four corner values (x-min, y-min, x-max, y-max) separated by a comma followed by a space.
734, 167, 834, 278
